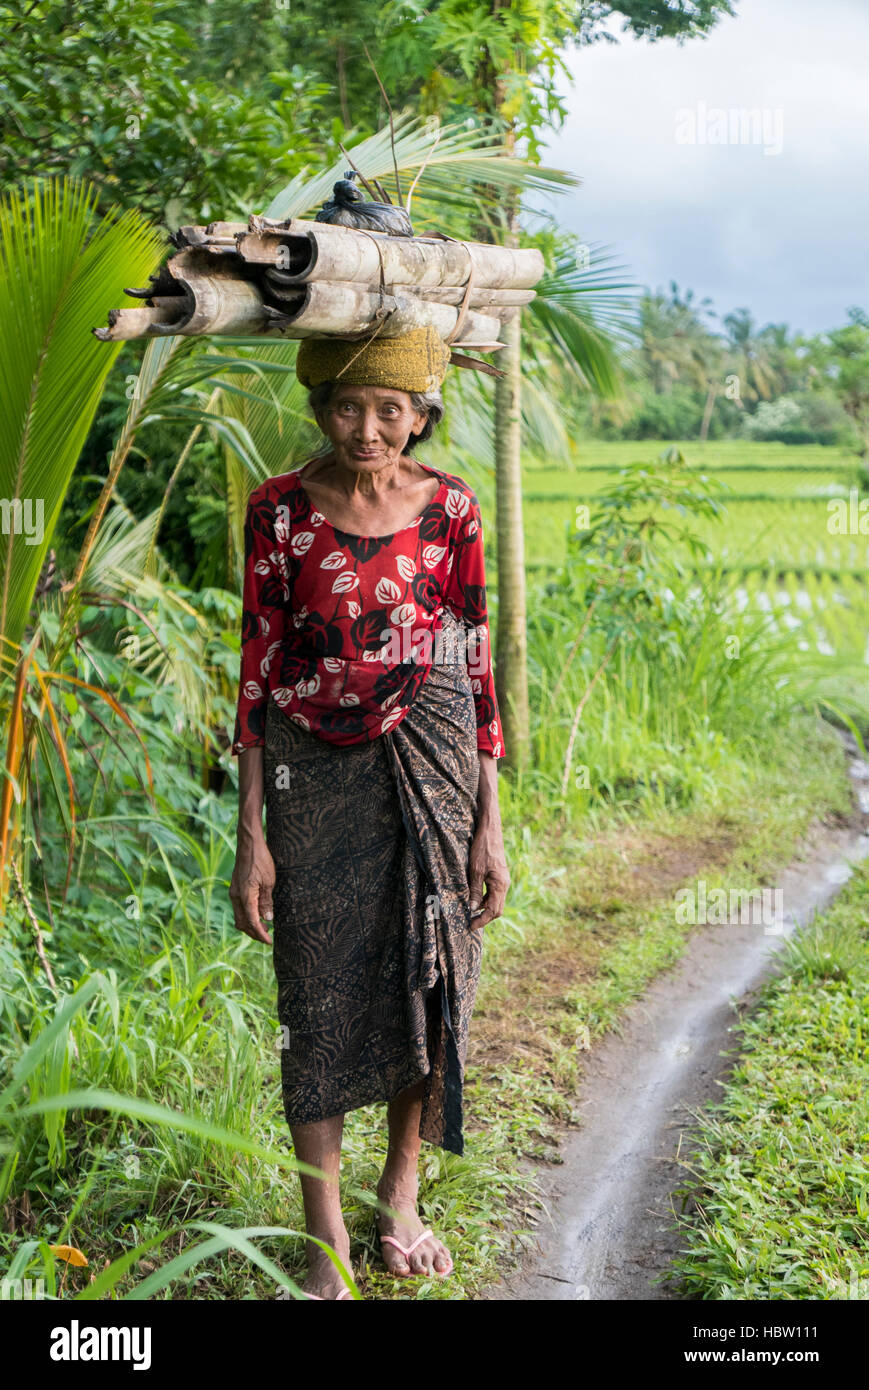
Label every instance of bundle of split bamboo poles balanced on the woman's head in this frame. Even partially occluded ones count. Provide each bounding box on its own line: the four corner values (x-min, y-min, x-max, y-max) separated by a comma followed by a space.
93, 217, 544, 352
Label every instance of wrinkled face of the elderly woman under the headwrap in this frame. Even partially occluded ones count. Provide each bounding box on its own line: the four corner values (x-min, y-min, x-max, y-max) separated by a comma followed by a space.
317, 384, 425, 473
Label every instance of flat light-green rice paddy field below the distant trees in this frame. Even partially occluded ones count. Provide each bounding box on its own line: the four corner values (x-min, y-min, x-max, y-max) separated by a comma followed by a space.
524, 441, 869, 663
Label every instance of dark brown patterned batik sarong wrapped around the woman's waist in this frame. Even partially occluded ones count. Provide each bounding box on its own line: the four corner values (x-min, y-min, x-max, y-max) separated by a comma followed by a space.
264, 610, 482, 1154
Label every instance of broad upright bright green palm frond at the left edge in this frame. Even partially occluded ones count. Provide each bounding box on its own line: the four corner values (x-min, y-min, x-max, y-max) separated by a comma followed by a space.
0, 179, 163, 644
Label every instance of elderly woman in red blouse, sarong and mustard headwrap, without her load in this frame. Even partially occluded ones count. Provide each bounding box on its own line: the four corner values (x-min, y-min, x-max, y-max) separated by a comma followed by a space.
229, 329, 509, 1298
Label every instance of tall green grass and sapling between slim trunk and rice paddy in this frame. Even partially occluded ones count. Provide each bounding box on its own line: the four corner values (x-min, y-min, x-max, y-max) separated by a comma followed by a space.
506, 455, 869, 821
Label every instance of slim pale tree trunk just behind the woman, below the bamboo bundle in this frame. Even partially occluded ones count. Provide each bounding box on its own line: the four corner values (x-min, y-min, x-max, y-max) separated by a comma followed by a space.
495, 300, 528, 767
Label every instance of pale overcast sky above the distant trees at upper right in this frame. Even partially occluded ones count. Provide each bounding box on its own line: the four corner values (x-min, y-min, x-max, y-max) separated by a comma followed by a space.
544, 0, 869, 332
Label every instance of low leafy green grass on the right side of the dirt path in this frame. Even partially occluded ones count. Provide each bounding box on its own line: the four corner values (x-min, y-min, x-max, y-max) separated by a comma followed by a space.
670, 862, 869, 1301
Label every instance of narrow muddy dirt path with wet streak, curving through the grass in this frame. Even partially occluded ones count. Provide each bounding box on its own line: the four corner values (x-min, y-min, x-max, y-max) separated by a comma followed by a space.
482, 755, 869, 1301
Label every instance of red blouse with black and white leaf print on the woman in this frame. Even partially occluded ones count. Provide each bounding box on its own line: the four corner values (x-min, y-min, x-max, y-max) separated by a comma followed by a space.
231, 464, 503, 758
